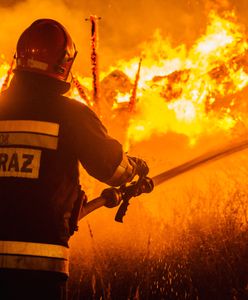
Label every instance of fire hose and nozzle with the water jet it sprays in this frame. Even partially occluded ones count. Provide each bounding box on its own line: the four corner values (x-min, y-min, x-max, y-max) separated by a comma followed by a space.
79, 140, 248, 222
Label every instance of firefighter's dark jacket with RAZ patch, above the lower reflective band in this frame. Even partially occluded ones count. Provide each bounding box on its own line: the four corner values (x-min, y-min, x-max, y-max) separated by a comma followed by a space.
0, 73, 123, 246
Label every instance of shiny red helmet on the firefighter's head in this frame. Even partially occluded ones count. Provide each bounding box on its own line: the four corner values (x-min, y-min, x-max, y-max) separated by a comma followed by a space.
15, 19, 77, 81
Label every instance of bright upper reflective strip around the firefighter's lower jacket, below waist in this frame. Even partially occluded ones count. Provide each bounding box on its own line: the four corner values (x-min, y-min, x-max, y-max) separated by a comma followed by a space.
0, 241, 69, 260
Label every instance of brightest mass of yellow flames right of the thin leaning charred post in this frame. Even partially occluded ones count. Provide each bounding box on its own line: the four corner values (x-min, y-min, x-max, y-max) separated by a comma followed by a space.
116, 12, 248, 144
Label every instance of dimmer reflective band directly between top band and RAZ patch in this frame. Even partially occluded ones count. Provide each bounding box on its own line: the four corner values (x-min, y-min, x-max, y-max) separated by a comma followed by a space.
0, 132, 58, 150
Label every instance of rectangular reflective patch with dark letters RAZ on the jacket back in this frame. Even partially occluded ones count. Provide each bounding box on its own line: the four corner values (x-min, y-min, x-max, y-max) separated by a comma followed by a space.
0, 147, 41, 178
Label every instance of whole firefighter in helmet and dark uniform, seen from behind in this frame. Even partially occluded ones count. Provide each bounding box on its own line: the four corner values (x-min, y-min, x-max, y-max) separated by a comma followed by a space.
0, 19, 148, 300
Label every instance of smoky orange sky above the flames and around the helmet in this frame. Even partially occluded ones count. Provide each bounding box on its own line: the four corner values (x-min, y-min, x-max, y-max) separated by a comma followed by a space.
0, 0, 248, 73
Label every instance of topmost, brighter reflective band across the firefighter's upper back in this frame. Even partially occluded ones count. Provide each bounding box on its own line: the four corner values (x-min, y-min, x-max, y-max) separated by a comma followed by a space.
0, 120, 59, 136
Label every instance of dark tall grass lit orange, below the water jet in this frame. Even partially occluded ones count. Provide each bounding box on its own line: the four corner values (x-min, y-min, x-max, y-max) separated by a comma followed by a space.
70, 169, 248, 300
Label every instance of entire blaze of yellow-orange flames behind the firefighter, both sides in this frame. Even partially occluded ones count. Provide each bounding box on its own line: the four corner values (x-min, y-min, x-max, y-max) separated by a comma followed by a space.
0, 11, 248, 149
